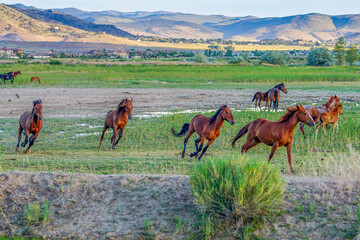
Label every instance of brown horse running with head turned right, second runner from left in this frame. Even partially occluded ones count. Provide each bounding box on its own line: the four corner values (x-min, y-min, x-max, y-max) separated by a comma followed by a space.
99, 98, 133, 149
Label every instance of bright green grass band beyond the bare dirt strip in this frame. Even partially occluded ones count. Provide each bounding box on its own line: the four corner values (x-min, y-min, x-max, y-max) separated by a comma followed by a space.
0, 60, 360, 92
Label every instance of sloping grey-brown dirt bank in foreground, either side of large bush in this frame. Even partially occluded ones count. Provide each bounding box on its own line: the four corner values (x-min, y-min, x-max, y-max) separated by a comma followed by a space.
0, 172, 360, 239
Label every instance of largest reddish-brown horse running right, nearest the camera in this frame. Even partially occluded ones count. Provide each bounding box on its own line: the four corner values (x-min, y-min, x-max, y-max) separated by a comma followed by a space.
232, 105, 315, 172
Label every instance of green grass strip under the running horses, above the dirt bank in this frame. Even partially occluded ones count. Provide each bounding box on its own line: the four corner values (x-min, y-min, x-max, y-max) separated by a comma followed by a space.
0, 104, 360, 175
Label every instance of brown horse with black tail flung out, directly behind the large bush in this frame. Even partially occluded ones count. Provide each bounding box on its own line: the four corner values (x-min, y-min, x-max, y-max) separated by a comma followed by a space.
172, 105, 235, 160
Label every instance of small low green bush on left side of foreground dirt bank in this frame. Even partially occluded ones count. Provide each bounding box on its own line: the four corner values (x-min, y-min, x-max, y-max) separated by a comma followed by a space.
23, 200, 52, 225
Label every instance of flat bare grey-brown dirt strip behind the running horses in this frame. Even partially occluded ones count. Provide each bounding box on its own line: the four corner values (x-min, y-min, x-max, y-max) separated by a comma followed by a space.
0, 88, 360, 118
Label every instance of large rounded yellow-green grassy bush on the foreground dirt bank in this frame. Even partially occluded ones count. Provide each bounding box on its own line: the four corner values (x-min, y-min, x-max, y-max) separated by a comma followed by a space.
190, 158, 285, 236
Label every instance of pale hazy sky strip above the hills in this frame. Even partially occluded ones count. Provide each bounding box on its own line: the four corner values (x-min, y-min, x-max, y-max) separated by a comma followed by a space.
3, 0, 360, 17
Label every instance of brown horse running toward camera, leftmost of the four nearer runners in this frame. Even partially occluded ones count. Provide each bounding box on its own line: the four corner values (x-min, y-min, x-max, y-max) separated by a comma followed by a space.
15, 99, 43, 153
